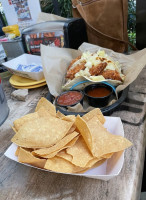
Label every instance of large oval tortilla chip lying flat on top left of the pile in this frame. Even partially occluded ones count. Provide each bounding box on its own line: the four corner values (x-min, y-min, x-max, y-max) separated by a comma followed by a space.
11, 115, 73, 148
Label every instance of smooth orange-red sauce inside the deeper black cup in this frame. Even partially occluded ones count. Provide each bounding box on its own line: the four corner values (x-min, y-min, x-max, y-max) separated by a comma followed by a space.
87, 87, 111, 97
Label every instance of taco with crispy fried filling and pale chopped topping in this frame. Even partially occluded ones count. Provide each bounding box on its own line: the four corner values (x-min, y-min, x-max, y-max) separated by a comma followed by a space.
63, 50, 125, 90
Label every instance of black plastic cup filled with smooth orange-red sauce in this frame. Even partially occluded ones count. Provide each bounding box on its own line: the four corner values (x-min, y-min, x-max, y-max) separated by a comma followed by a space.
84, 83, 113, 108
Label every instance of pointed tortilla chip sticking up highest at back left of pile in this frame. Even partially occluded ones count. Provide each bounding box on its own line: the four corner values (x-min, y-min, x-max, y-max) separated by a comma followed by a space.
35, 97, 56, 116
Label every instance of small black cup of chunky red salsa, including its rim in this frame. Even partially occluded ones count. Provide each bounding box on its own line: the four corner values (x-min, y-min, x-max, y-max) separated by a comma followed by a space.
55, 90, 84, 108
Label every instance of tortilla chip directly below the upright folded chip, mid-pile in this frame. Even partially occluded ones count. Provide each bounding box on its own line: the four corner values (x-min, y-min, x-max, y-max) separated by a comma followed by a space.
66, 136, 93, 168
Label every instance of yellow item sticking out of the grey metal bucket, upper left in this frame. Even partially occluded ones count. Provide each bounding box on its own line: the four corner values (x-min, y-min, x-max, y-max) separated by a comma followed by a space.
2, 24, 20, 36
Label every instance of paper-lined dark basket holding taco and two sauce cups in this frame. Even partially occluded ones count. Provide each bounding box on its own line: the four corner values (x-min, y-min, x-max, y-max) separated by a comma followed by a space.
41, 43, 145, 115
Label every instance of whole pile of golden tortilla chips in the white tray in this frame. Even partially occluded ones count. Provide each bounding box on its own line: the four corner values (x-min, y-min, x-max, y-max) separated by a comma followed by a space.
12, 98, 132, 173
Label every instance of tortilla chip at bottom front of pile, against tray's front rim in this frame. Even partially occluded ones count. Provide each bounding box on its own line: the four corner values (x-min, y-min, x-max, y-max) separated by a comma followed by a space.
44, 156, 82, 173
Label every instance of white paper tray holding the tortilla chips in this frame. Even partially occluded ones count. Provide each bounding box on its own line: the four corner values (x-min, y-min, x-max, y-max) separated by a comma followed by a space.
4, 117, 124, 181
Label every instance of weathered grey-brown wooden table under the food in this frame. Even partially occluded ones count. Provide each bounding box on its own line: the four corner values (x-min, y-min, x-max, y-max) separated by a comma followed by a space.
0, 68, 146, 200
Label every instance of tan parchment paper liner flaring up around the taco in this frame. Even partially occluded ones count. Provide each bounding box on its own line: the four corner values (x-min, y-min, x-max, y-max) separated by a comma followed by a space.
41, 43, 146, 96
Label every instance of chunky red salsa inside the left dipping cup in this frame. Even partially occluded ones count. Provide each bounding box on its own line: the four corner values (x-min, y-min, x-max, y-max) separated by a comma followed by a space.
57, 91, 83, 106
